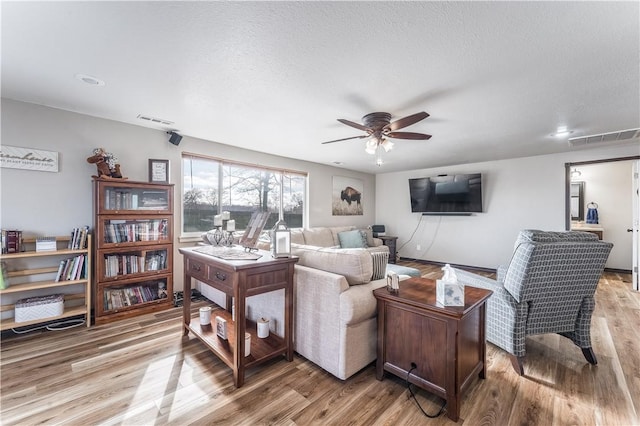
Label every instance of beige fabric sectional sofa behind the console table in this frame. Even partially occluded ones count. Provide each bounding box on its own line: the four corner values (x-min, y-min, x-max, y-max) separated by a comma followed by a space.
199, 226, 400, 379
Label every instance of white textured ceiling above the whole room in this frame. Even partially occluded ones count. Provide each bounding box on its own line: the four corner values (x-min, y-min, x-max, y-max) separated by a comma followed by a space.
1, 1, 640, 173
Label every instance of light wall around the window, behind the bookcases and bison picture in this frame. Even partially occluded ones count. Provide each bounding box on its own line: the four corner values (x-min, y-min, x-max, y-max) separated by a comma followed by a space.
0, 99, 375, 290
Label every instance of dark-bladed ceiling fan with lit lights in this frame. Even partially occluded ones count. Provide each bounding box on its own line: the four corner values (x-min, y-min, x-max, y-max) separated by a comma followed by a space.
322, 111, 431, 154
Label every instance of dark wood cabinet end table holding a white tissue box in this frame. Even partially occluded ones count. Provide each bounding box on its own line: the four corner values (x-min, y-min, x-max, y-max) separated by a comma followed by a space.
373, 278, 492, 421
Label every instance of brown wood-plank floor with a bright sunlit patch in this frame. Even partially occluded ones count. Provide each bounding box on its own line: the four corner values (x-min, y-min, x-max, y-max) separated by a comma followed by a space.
0, 262, 640, 426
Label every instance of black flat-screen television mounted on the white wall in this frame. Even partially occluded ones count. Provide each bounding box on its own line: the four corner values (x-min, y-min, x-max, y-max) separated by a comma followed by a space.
409, 173, 482, 215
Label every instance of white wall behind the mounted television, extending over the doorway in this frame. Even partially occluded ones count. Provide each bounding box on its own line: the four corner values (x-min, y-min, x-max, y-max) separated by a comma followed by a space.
376, 141, 640, 269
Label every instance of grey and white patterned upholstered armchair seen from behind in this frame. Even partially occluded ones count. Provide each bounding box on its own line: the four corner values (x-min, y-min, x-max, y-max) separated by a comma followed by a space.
456, 230, 613, 375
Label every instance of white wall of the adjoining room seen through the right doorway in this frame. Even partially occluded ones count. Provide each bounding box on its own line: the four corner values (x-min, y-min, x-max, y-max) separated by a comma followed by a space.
576, 161, 633, 269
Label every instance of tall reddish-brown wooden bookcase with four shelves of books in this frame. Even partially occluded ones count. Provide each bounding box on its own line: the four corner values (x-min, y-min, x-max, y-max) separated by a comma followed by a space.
93, 179, 173, 324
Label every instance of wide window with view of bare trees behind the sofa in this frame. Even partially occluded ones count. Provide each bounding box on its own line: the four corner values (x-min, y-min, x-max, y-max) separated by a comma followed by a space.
182, 153, 307, 236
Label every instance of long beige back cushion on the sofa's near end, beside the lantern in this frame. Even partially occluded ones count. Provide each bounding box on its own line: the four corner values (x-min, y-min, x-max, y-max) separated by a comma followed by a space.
291, 245, 373, 285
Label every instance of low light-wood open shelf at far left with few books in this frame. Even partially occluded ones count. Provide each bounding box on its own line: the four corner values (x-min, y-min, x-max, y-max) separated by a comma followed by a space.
0, 234, 91, 330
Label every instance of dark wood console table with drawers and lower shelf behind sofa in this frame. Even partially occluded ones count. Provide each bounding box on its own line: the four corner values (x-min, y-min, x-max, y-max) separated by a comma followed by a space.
179, 247, 298, 388
